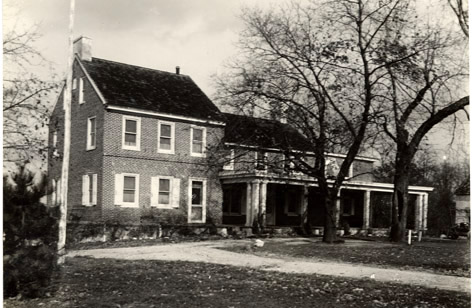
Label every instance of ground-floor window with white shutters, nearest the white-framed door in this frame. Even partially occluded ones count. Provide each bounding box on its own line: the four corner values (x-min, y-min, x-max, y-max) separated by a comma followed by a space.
151, 176, 180, 208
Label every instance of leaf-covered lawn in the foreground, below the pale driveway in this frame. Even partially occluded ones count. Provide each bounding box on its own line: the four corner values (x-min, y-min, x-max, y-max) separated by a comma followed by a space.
4, 258, 470, 308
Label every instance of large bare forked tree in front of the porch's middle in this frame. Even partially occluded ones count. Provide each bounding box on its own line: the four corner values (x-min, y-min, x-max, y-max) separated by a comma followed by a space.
218, 0, 420, 242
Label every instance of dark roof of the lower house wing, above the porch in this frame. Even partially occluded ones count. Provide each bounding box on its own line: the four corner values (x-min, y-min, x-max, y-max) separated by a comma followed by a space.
224, 113, 313, 151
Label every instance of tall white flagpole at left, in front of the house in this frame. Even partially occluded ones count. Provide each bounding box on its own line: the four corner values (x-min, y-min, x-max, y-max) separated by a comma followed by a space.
57, 0, 75, 264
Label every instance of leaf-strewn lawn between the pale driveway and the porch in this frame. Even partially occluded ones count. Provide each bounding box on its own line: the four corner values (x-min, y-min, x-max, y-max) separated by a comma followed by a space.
223, 238, 470, 277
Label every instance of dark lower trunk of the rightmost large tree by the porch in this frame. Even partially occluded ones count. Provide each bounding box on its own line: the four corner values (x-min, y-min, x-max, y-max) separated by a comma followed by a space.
390, 158, 411, 242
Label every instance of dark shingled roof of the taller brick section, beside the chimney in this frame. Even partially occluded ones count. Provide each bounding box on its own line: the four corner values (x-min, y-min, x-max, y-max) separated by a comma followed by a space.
81, 58, 221, 120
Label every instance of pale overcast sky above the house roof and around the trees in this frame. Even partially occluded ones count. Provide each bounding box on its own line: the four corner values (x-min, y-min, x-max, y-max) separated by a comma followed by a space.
3, 0, 469, 160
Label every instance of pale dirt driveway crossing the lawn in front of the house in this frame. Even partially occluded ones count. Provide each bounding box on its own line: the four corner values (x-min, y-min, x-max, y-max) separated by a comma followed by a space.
68, 240, 471, 293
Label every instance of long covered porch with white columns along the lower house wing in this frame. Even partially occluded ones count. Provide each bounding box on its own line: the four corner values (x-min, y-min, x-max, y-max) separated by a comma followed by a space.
222, 176, 432, 231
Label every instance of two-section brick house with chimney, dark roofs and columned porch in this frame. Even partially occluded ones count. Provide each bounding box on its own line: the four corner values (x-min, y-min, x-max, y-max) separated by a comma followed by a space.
48, 37, 432, 233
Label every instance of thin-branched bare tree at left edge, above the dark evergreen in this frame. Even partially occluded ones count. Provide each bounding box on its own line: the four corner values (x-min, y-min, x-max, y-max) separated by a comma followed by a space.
3, 29, 57, 167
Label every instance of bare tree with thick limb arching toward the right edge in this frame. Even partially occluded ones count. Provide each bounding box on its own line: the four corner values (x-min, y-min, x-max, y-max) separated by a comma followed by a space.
374, 11, 469, 241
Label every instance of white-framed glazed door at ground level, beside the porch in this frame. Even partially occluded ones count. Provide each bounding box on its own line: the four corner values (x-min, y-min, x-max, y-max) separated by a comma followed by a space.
188, 178, 206, 223
